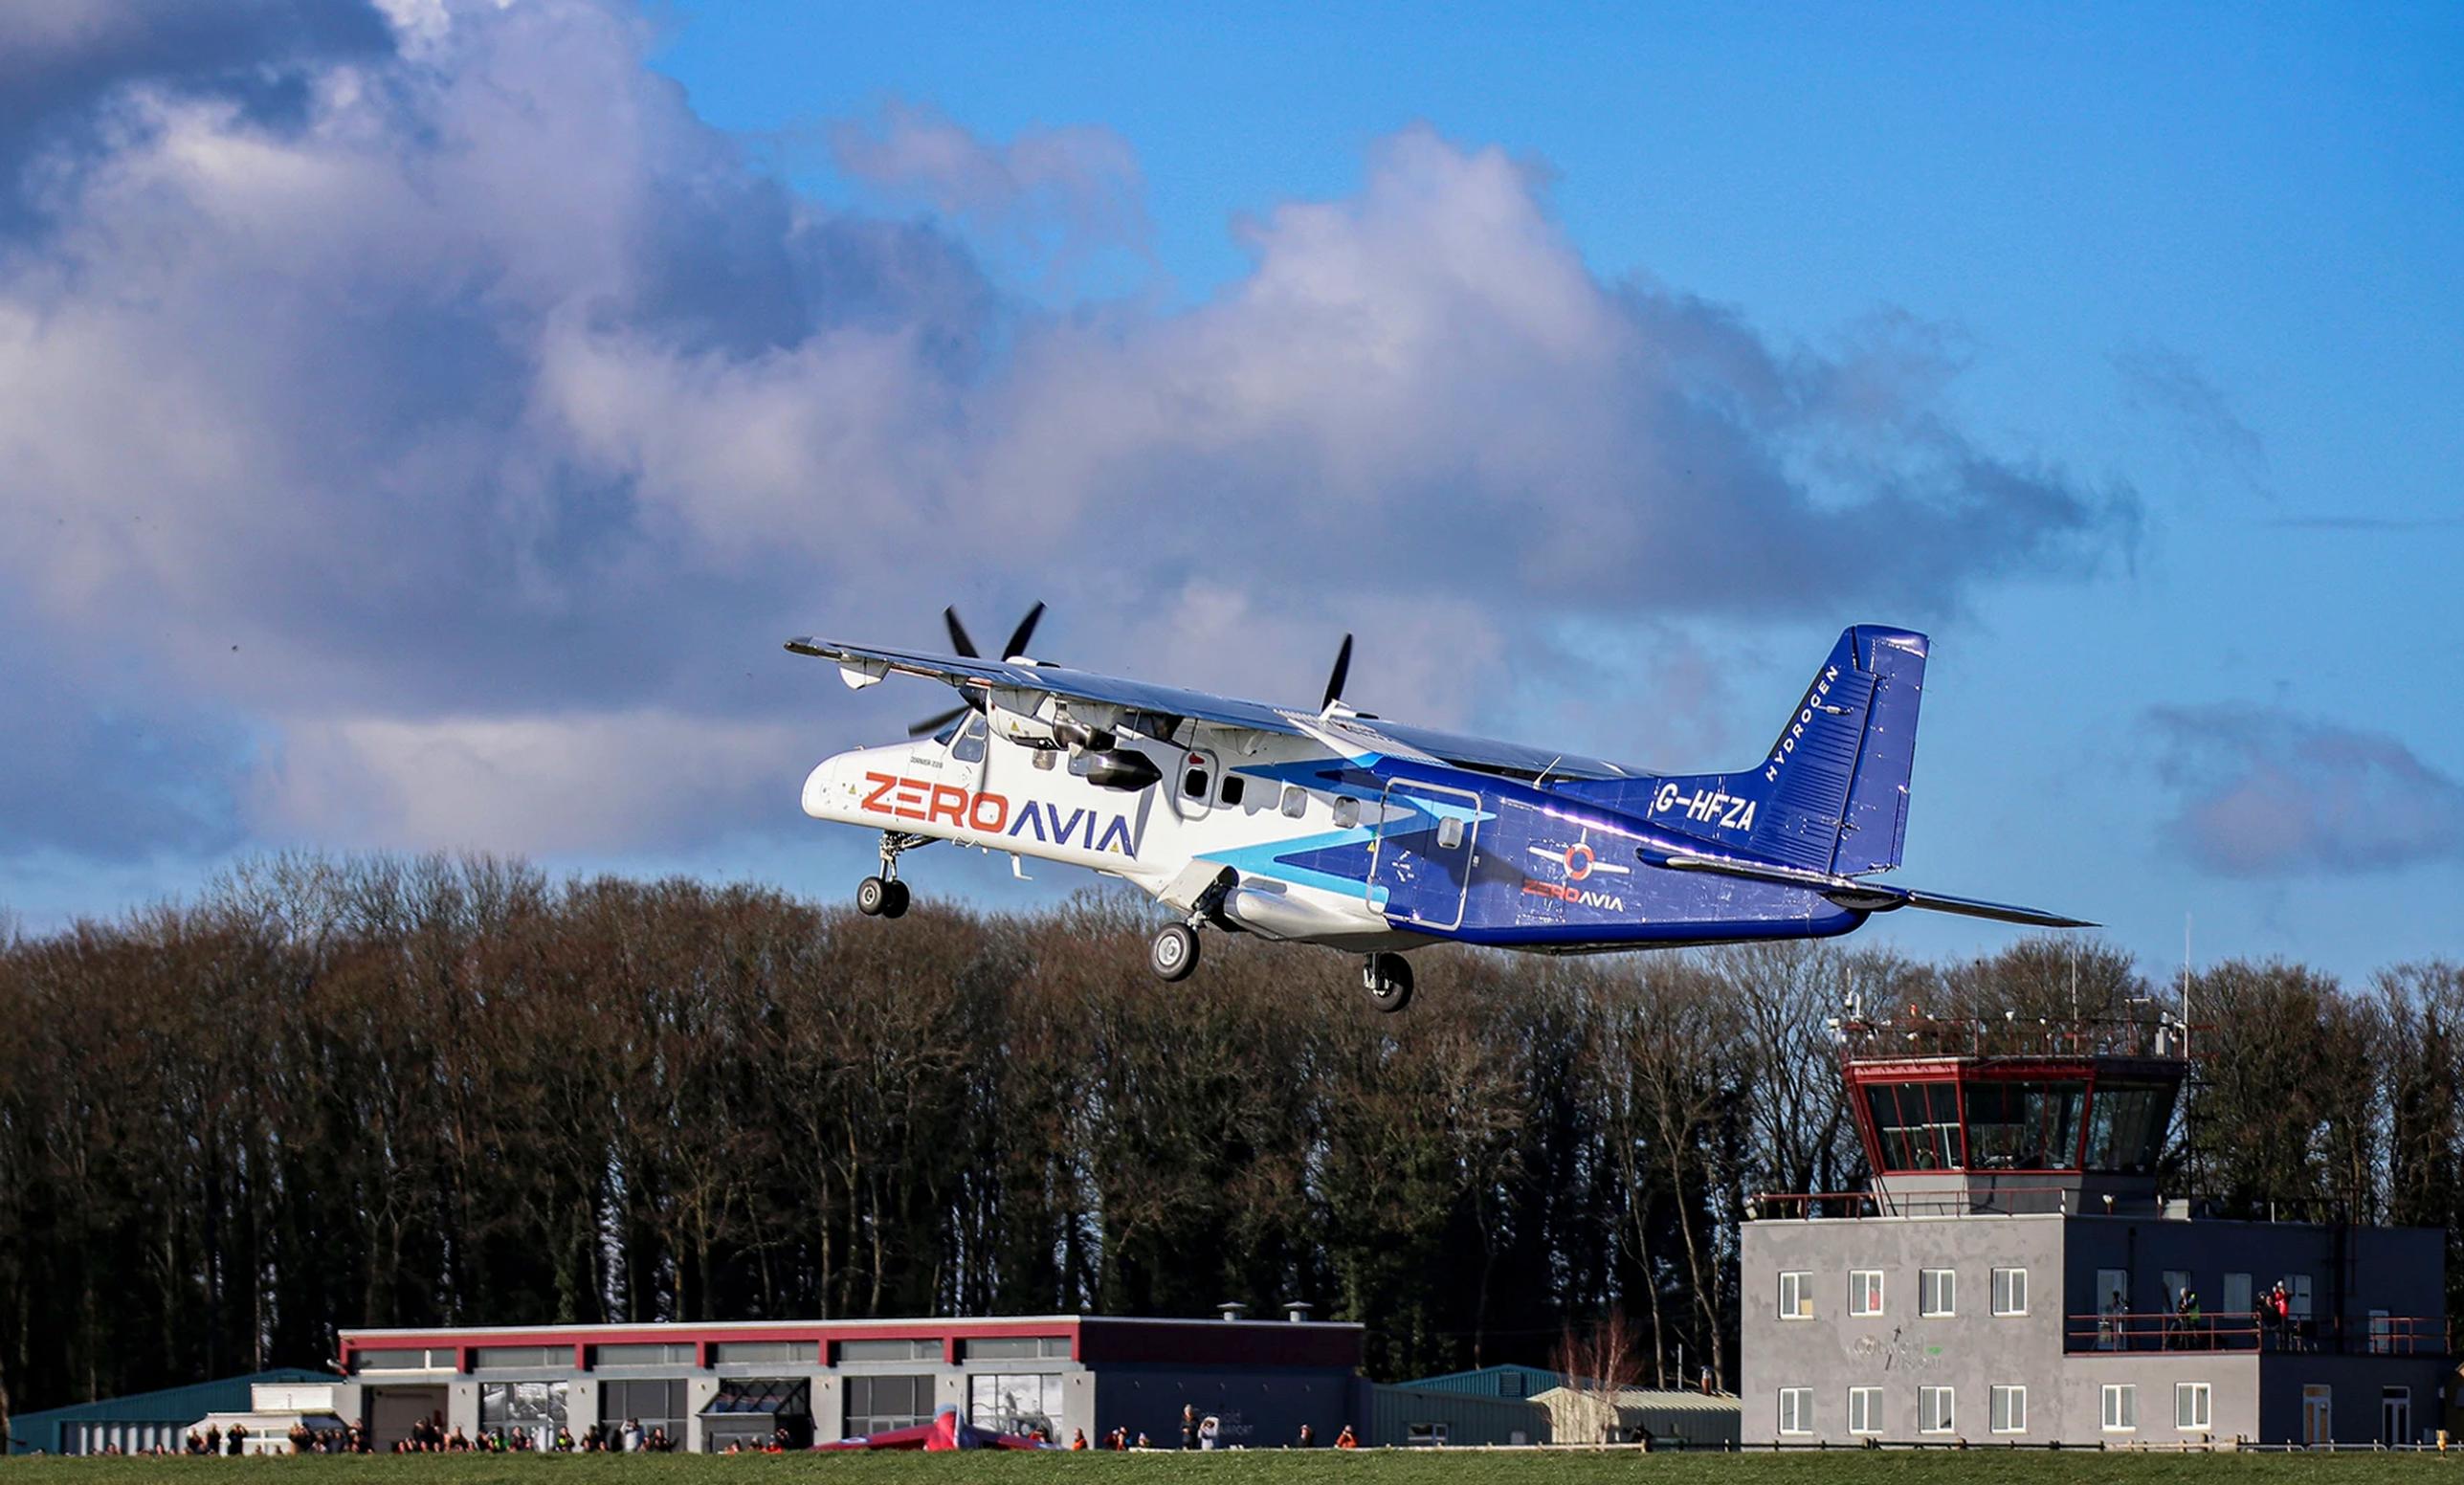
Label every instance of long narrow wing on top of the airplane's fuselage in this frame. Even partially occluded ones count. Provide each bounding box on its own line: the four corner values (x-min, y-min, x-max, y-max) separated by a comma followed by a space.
786, 638, 1646, 778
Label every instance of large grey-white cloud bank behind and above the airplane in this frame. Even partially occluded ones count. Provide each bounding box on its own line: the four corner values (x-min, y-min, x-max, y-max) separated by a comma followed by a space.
0, 0, 2134, 872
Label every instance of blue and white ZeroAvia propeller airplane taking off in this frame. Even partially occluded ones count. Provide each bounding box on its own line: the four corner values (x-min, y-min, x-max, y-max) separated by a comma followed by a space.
786, 604, 2095, 1012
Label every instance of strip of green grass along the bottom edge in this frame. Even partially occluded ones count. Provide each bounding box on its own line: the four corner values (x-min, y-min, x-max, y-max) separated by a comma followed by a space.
0, 1448, 2464, 1485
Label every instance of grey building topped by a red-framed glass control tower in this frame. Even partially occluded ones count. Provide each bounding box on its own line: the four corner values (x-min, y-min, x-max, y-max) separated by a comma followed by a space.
1740, 1027, 2456, 1448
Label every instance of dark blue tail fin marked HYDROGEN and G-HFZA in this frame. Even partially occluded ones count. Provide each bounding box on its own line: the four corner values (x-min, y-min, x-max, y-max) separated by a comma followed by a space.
1560, 623, 1924, 876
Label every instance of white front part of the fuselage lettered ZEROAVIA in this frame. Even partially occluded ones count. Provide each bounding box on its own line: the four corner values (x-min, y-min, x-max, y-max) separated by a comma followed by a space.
803, 717, 1424, 948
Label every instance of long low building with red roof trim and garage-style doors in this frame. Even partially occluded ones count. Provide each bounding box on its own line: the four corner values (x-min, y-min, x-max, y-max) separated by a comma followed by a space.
335, 1310, 1372, 1451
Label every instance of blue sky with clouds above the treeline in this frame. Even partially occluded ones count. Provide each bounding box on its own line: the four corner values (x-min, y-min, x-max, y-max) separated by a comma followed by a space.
0, 0, 2464, 978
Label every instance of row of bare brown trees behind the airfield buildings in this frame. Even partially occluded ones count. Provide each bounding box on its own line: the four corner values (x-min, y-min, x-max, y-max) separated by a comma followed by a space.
0, 857, 2464, 1411
